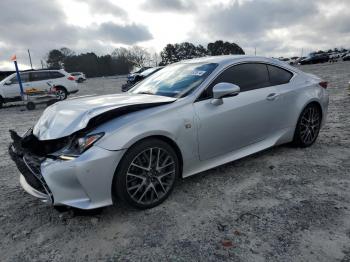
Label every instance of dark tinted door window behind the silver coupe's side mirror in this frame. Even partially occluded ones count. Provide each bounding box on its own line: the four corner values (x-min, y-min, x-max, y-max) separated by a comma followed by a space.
199, 63, 270, 100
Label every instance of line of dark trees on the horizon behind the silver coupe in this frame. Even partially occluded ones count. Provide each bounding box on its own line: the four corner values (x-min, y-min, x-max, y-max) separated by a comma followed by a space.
45, 40, 244, 77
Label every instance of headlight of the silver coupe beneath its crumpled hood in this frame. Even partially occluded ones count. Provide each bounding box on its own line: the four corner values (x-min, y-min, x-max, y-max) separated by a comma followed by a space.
59, 133, 104, 160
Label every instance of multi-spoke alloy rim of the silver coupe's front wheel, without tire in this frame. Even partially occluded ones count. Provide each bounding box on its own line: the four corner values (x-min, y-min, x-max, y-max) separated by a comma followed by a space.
126, 147, 176, 205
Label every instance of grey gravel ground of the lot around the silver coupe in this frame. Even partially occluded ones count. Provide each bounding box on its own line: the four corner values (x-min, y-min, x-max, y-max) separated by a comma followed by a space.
0, 62, 350, 261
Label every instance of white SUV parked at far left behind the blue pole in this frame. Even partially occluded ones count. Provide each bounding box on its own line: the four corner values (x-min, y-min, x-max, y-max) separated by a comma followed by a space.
0, 70, 79, 108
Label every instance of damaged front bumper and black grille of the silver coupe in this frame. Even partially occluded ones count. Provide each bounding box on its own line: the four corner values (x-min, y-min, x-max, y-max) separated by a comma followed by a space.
9, 130, 125, 209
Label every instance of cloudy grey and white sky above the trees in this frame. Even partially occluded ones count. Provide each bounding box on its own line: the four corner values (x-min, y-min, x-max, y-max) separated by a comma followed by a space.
0, 0, 350, 70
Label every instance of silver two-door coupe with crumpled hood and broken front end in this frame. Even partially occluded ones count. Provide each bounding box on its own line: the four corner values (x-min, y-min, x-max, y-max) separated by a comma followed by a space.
9, 56, 328, 209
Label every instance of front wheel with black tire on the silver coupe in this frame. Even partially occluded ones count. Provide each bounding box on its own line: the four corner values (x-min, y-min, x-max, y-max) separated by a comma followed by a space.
113, 138, 180, 209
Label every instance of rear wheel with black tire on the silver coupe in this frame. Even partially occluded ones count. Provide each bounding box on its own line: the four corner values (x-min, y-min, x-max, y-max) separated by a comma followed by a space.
293, 104, 322, 147
